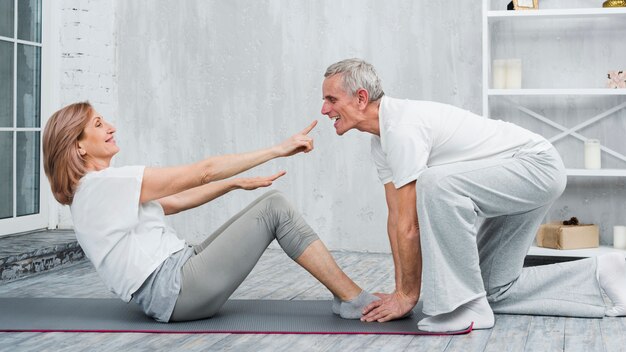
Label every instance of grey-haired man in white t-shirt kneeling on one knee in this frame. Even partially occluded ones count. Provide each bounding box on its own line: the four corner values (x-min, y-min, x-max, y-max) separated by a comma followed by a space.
322, 59, 626, 332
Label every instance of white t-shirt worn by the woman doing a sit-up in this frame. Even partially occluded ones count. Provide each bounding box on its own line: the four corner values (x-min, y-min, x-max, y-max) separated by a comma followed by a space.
70, 166, 185, 302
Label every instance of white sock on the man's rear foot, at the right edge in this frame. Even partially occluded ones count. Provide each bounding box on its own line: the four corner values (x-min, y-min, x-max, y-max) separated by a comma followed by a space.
596, 253, 626, 317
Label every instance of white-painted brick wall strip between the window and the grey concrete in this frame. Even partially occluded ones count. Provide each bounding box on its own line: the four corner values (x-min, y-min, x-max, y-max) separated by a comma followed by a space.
52, 0, 118, 228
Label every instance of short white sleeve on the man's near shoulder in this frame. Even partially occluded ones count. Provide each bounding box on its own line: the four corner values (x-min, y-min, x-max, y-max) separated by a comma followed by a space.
385, 124, 431, 189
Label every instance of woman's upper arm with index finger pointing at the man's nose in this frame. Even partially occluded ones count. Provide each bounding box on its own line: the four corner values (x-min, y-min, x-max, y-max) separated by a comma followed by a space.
140, 121, 317, 203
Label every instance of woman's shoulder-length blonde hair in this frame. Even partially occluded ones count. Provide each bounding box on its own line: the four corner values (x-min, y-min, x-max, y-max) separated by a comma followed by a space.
43, 101, 93, 205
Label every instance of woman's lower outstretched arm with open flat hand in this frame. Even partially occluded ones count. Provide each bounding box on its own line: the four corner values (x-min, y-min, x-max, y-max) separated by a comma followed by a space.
157, 171, 285, 215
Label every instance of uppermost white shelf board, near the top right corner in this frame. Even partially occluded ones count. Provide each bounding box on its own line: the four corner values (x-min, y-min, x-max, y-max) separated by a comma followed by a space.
487, 7, 626, 19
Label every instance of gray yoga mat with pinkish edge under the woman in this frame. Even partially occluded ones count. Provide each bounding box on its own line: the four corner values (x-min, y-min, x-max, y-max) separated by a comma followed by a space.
0, 298, 471, 335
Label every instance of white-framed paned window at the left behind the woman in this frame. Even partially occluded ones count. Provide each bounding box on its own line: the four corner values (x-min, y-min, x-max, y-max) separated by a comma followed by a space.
0, 0, 47, 235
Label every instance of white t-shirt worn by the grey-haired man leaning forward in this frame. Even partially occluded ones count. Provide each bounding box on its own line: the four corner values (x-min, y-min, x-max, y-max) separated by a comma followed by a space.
372, 96, 551, 188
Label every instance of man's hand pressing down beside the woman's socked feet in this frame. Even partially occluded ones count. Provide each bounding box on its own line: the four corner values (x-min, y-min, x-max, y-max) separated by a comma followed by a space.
361, 292, 417, 323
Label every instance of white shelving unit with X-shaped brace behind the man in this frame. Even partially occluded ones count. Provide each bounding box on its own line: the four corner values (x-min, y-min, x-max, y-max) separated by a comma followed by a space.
482, 0, 626, 257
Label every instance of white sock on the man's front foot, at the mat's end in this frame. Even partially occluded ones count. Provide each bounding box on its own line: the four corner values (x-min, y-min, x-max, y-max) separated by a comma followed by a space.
417, 296, 494, 332
